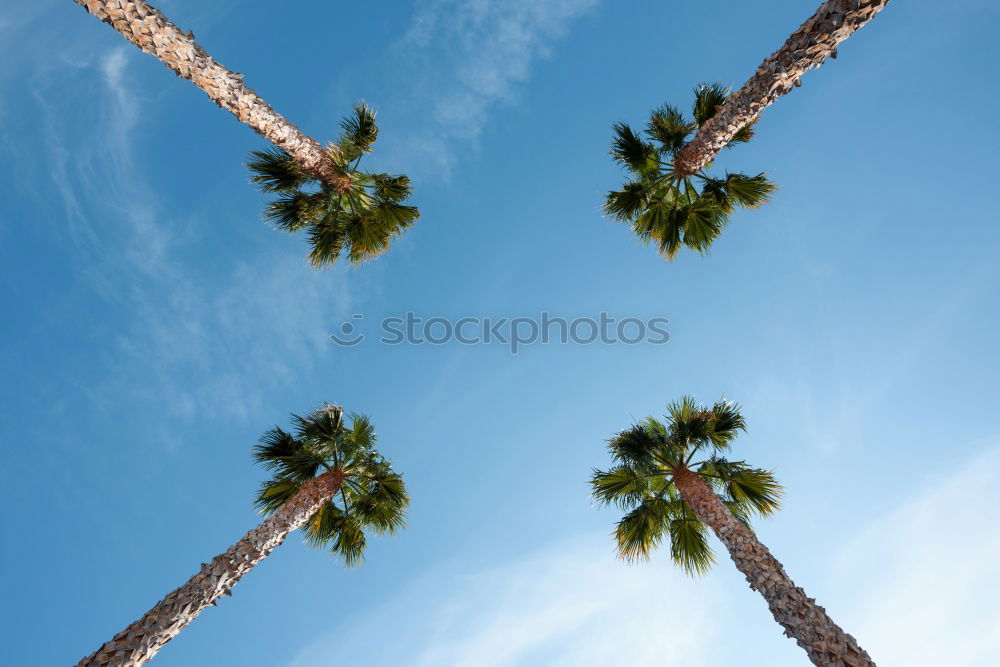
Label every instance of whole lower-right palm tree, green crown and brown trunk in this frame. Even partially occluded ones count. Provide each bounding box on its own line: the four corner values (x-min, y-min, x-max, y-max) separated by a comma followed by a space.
590, 396, 875, 667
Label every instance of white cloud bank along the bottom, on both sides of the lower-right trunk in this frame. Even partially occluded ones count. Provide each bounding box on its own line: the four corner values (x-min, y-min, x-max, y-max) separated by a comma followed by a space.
290, 446, 1000, 667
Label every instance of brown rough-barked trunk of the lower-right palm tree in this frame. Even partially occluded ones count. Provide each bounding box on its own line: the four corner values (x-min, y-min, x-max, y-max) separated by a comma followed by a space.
673, 467, 875, 667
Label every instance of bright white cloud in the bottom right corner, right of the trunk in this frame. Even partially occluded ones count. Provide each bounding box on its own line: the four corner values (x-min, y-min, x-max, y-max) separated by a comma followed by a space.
836, 447, 1000, 667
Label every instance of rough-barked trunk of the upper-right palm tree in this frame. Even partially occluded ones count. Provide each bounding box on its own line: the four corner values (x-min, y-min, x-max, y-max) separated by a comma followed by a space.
674, 0, 889, 176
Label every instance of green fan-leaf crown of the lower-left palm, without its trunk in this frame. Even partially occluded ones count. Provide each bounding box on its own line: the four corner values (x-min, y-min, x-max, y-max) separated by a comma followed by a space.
253, 405, 410, 566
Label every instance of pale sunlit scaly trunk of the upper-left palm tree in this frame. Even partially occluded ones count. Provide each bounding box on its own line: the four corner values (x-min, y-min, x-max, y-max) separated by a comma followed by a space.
73, 0, 350, 189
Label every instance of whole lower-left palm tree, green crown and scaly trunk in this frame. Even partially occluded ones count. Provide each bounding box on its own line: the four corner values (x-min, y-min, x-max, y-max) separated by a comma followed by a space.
77, 404, 410, 667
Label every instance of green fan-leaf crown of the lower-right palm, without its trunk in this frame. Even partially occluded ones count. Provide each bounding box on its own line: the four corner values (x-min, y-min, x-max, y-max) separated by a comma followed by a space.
590, 396, 781, 574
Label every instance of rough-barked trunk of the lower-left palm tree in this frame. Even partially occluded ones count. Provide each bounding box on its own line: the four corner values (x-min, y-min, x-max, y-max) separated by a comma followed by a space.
77, 470, 344, 667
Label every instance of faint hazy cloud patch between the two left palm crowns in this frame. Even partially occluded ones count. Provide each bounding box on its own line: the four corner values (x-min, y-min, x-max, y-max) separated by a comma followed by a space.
100, 252, 350, 418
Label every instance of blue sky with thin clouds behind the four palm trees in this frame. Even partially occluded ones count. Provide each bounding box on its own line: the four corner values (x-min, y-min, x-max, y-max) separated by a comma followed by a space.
0, 0, 1000, 667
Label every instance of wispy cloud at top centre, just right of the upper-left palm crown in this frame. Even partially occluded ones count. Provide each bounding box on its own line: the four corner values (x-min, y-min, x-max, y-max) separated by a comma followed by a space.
380, 0, 599, 180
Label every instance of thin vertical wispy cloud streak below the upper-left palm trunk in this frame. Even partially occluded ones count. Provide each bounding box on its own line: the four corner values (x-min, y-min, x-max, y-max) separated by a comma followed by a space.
31, 45, 181, 288
